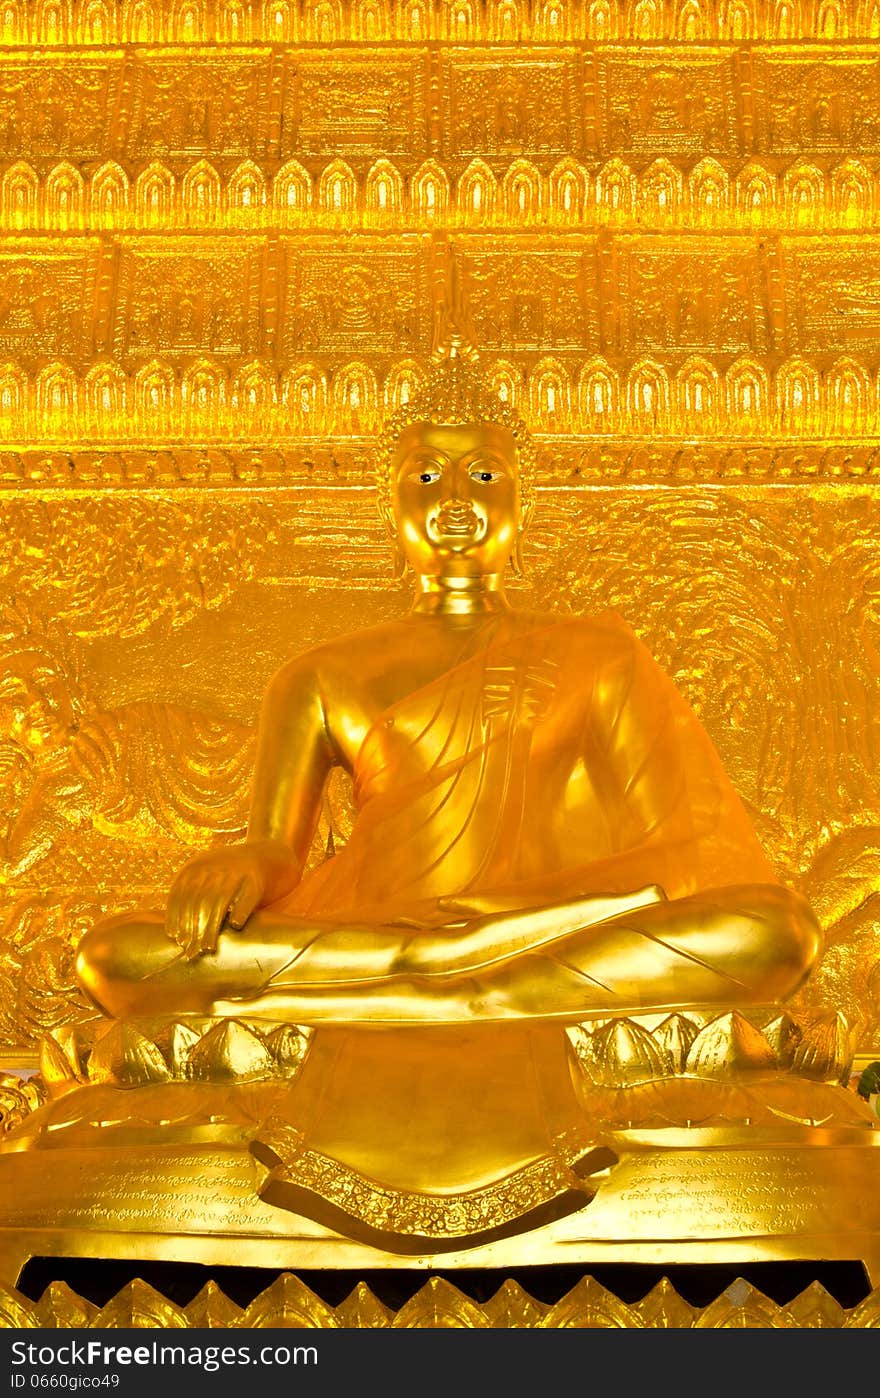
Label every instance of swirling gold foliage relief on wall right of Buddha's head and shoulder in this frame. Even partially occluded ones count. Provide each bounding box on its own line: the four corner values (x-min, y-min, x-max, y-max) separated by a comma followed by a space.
536, 489, 880, 874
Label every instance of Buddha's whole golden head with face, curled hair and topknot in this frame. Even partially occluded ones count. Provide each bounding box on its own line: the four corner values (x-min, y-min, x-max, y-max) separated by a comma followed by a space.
379, 354, 534, 577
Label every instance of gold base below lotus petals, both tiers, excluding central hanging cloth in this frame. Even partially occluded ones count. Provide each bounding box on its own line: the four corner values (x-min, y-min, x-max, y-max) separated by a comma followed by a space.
0, 1075, 880, 1286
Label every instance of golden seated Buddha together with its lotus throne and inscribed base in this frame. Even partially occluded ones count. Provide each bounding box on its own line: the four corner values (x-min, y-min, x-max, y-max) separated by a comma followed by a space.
0, 341, 880, 1276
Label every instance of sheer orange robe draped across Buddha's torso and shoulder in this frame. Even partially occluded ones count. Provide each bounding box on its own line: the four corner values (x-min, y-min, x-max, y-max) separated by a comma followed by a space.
278, 612, 775, 924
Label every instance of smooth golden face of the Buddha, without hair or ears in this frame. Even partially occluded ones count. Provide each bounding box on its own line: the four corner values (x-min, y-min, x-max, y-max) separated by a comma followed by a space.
392, 422, 522, 577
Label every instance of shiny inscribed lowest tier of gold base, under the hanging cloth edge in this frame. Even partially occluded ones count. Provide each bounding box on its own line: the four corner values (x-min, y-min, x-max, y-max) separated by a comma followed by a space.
0, 1131, 880, 1285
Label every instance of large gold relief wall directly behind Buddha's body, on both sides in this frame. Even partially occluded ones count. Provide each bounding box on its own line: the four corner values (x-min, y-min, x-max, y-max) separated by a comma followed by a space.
0, 478, 880, 1044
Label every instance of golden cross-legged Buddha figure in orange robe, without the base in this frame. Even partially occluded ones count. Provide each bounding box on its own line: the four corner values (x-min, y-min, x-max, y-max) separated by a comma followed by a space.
78, 352, 820, 1026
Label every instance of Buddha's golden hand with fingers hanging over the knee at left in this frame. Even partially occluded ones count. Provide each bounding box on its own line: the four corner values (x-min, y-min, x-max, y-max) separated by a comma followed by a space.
165, 842, 299, 960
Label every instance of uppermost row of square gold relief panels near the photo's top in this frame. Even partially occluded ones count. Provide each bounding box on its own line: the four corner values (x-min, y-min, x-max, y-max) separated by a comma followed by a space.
0, 46, 880, 171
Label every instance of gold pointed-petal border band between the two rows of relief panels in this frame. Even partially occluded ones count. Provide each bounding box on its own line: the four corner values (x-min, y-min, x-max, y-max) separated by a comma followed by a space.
0, 157, 880, 233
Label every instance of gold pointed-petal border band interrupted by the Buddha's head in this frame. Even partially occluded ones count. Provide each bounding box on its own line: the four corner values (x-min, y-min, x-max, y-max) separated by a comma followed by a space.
0, 355, 880, 450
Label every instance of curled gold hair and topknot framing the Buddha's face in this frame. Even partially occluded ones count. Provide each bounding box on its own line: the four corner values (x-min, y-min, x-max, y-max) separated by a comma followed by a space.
376, 355, 537, 520
